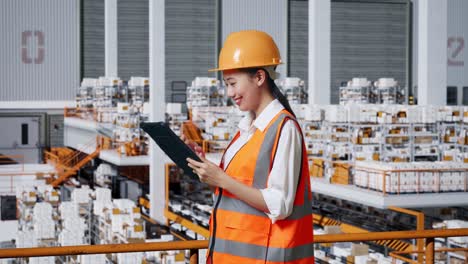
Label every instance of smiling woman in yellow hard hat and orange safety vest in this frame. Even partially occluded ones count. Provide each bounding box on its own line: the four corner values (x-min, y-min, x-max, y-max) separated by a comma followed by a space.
186, 30, 314, 264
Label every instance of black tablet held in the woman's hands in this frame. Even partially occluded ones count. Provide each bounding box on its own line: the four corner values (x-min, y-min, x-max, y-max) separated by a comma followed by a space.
140, 122, 201, 179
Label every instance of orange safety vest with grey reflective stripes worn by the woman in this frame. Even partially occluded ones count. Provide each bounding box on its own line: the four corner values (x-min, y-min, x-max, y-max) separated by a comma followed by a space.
207, 110, 314, 264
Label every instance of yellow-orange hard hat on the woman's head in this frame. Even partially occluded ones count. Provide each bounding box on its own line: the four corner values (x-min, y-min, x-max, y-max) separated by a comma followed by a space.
208, 30, 282, 71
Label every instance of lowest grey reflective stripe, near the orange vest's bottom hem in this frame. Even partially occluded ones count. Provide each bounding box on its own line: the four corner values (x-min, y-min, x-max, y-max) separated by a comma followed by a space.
214, 237, 314, 262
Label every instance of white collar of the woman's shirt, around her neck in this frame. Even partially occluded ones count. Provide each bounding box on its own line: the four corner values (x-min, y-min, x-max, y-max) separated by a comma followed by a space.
238, 99, 284, 133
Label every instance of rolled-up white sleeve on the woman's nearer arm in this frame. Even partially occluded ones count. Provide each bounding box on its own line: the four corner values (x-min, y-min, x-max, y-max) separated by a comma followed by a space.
260, 120, 302, 223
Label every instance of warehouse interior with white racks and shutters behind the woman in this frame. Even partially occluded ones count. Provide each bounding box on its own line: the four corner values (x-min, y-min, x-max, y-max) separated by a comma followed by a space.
0, 0, 468, 264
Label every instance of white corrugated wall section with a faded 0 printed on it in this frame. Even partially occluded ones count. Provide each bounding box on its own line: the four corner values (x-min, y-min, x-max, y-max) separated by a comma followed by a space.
0, 0, 80, 105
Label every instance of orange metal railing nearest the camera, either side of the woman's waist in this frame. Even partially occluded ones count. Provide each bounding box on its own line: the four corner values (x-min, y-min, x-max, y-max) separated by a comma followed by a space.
0, 228, 468, 264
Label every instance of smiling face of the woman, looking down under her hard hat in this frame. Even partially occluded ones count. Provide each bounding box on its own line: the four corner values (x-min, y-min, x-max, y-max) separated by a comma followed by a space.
223, 70, 261, 111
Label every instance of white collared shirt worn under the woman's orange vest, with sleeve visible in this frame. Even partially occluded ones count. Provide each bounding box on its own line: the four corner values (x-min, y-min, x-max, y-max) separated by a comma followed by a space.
224, 100, 302, 223
